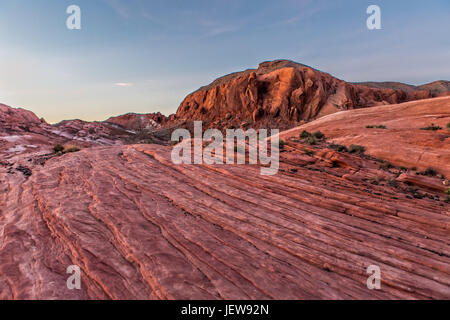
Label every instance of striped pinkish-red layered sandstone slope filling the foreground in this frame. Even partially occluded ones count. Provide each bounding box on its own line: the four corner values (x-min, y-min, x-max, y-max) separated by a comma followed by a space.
0, 139, 450, 299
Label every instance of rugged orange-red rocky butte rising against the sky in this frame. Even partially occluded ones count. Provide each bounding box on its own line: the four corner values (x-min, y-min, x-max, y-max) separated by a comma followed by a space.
176, 60, 442, 128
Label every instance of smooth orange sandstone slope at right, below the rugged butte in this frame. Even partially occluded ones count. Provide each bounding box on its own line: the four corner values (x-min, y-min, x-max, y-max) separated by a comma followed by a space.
281, 97, 450, 178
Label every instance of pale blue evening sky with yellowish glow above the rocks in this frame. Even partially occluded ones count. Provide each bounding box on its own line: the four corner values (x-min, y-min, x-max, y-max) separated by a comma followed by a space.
0, 0, 450, 123
